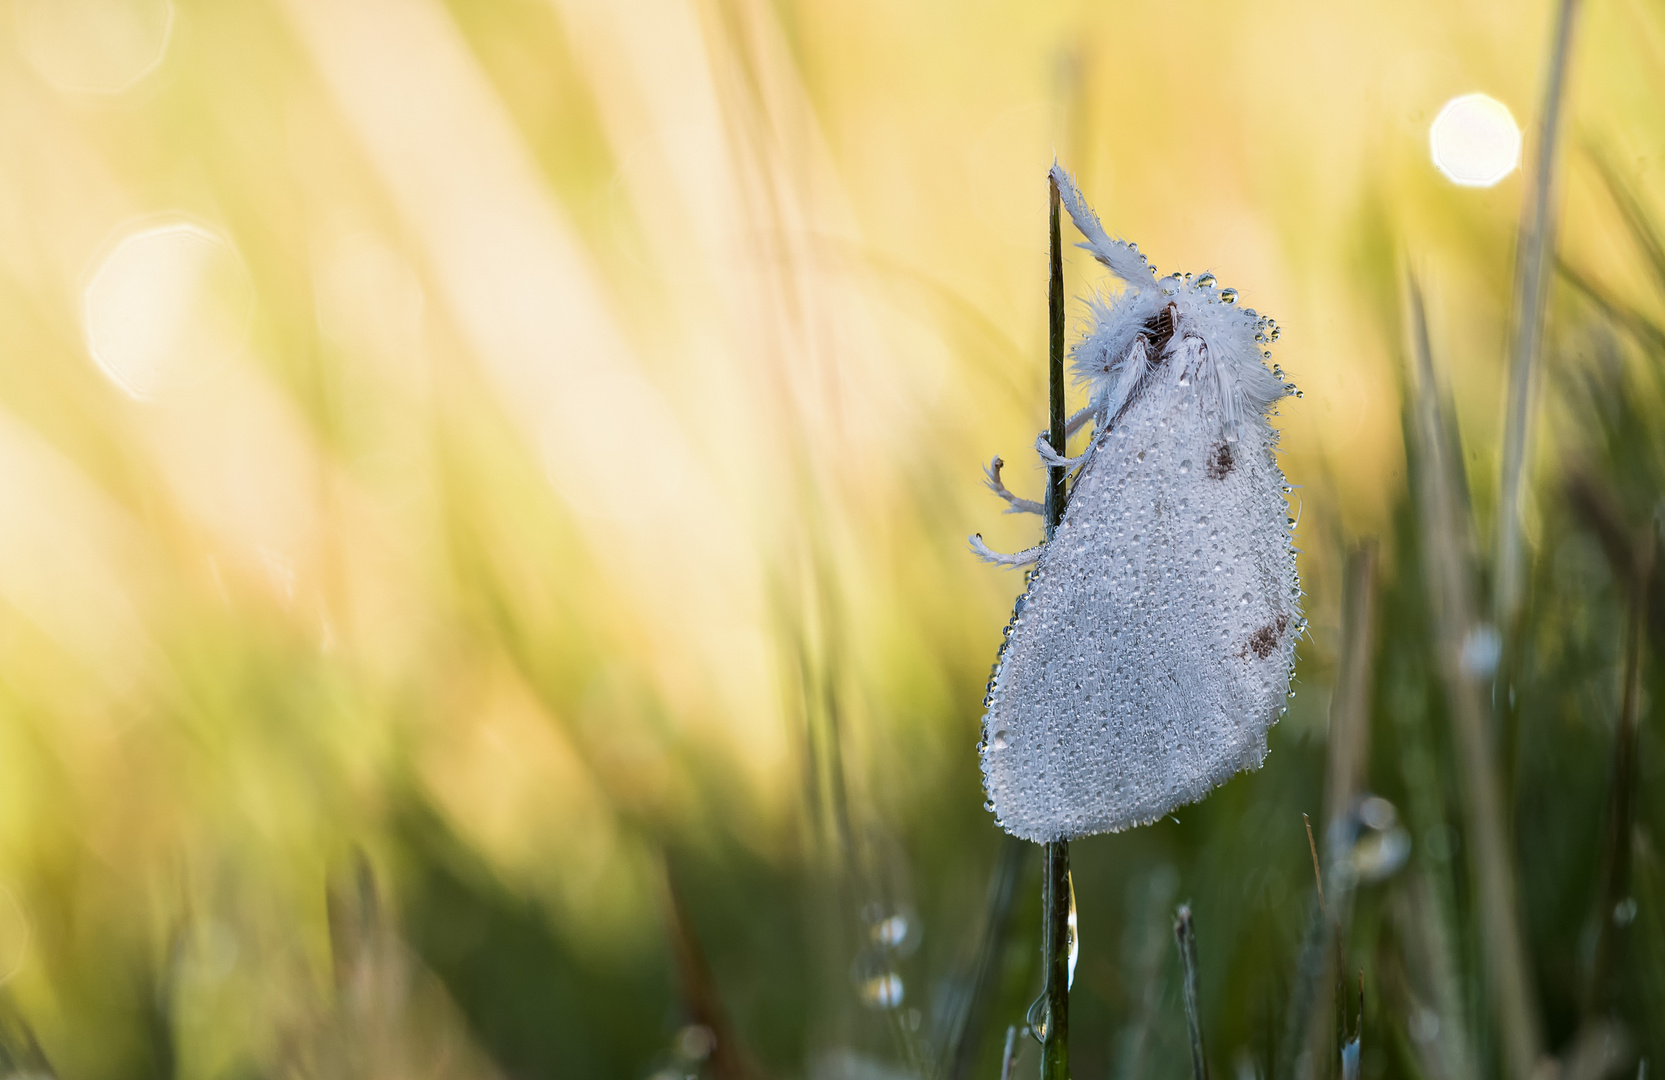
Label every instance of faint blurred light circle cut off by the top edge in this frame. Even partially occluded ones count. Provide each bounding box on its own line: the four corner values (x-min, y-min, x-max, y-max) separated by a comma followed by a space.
17, 0, 173, 93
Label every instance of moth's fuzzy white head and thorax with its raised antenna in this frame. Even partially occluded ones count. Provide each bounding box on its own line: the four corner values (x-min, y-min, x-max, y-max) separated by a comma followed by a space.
1052, 163, 1294, 443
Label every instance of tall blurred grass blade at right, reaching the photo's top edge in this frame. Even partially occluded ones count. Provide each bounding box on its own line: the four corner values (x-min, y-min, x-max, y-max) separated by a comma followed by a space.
1492, 0, 1578, 629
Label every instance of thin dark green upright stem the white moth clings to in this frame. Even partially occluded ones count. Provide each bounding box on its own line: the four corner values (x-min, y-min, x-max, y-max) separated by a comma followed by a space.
1041, 166, 1069, 1080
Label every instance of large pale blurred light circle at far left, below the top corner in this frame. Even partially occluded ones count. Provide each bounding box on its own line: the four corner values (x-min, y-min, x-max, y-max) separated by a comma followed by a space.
82, 221, 255, 399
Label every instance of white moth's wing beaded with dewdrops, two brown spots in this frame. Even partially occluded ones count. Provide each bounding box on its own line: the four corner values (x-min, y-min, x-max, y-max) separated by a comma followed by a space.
982, 366, 1299, 840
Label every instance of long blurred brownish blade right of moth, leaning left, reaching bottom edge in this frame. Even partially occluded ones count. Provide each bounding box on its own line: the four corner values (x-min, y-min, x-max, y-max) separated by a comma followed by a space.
1409, 278, 1542, 1080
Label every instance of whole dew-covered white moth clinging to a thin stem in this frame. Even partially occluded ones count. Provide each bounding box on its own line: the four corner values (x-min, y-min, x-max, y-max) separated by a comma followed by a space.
971, 165, 1304, 840
